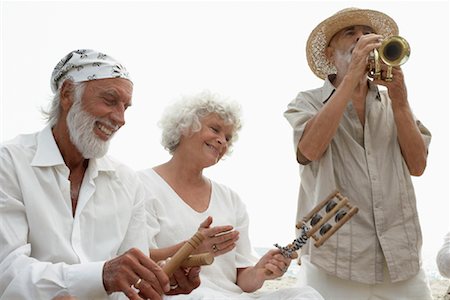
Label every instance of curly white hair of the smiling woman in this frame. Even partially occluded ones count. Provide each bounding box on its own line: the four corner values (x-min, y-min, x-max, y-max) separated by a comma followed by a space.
158, 91, 242, 154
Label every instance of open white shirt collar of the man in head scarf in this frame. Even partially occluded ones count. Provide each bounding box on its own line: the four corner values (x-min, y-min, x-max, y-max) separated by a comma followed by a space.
31, 125, 116, 177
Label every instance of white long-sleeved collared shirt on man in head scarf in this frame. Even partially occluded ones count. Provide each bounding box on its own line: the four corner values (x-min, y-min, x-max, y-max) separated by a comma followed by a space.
0, 126, 148, 300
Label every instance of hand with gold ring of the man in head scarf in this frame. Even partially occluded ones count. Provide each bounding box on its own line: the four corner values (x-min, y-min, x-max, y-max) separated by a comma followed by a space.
103, 248, 170, 300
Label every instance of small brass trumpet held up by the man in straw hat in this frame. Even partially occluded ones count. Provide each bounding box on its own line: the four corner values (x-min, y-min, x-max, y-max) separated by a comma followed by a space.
367, 35, 411, 81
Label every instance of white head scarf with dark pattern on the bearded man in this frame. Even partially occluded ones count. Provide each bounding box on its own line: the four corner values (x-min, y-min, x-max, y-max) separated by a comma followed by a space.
50, 49, 131, 93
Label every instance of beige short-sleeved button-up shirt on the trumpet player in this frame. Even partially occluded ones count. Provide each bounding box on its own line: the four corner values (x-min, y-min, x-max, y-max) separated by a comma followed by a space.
285, 78, 431, 284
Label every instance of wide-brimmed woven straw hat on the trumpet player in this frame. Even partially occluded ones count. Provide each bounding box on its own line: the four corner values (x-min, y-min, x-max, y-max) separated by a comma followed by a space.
306, 7, 398, 79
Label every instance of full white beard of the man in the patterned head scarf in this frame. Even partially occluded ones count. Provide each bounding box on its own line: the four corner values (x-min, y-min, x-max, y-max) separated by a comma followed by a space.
67, 99, 110, 159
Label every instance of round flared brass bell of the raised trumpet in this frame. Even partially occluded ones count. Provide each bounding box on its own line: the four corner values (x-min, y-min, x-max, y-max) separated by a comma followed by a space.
378, 36, 411, 67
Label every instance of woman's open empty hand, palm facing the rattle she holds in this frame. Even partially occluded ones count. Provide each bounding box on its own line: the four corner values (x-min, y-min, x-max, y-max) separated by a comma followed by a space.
194, 216, 239, 256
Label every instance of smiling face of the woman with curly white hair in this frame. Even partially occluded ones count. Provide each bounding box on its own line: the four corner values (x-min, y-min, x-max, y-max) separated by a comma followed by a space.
175, 113, 233, 168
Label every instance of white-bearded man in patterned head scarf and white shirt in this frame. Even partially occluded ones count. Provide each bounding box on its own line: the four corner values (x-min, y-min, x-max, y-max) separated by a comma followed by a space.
0, 50, 200, 299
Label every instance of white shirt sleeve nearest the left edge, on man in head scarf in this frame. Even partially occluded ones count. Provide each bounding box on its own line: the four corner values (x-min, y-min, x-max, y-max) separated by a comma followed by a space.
0, 149, 106, 299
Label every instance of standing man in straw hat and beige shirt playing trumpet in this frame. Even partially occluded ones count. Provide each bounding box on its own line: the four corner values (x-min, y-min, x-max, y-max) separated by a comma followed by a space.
285, 8, 431, 300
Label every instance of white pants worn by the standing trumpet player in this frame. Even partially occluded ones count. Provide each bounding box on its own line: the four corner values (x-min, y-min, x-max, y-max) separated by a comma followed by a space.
297, 255, 433, 300
